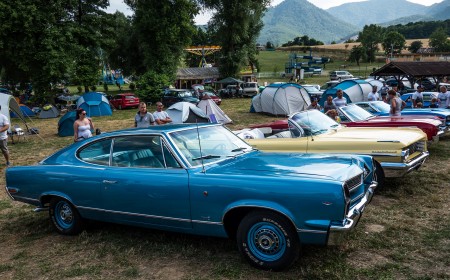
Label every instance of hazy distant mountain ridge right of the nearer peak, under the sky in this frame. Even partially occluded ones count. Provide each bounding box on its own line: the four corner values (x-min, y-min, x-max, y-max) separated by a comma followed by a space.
326, 0, 427, 26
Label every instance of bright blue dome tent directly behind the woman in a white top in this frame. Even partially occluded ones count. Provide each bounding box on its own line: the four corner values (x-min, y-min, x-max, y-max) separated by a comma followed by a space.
77, 92, 112, 117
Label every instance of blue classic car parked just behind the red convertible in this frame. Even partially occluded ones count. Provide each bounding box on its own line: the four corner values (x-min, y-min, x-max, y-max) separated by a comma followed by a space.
353, 101, 450, 126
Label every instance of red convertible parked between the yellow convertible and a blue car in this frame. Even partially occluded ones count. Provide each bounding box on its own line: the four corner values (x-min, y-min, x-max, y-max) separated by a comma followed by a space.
251, 104, 448, 142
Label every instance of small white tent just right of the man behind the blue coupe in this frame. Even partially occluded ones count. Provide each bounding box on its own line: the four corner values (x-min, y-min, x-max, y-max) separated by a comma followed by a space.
166, 102, 209, 123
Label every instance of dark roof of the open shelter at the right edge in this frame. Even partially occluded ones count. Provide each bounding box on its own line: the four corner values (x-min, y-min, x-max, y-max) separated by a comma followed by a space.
370, 61, 450, 77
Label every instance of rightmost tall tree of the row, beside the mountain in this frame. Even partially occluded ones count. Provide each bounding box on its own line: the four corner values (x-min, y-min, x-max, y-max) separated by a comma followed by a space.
200, 0, 270, 77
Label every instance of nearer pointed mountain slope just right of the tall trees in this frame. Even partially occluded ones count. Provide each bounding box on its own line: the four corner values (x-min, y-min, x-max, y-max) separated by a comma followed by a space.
258, 0, 361, 45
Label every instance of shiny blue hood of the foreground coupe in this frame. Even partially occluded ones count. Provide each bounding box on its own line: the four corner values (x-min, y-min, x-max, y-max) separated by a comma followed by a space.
206, 151, 363, 181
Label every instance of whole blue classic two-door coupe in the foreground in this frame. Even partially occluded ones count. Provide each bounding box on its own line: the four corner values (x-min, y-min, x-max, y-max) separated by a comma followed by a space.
6, 124, 377, 270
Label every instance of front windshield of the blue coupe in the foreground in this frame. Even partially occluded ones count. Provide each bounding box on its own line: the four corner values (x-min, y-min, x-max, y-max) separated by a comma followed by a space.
170, 126, 252, 166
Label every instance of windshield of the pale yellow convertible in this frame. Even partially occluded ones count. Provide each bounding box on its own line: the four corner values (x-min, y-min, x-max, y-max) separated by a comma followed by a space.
289, 110, 340, 136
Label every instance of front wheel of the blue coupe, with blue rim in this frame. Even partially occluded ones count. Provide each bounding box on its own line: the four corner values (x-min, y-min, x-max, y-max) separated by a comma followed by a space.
237, 211, 300, 271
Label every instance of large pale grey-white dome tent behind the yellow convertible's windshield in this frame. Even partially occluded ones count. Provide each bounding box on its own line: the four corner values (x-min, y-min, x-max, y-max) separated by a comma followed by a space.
252, 84, 311, 116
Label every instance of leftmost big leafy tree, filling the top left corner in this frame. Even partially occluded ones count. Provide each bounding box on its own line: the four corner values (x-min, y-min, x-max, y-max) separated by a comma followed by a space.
0, 0, 112, 103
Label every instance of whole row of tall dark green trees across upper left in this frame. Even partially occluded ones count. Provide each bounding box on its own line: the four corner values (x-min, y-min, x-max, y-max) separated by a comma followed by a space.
0, 0, 270, 102
